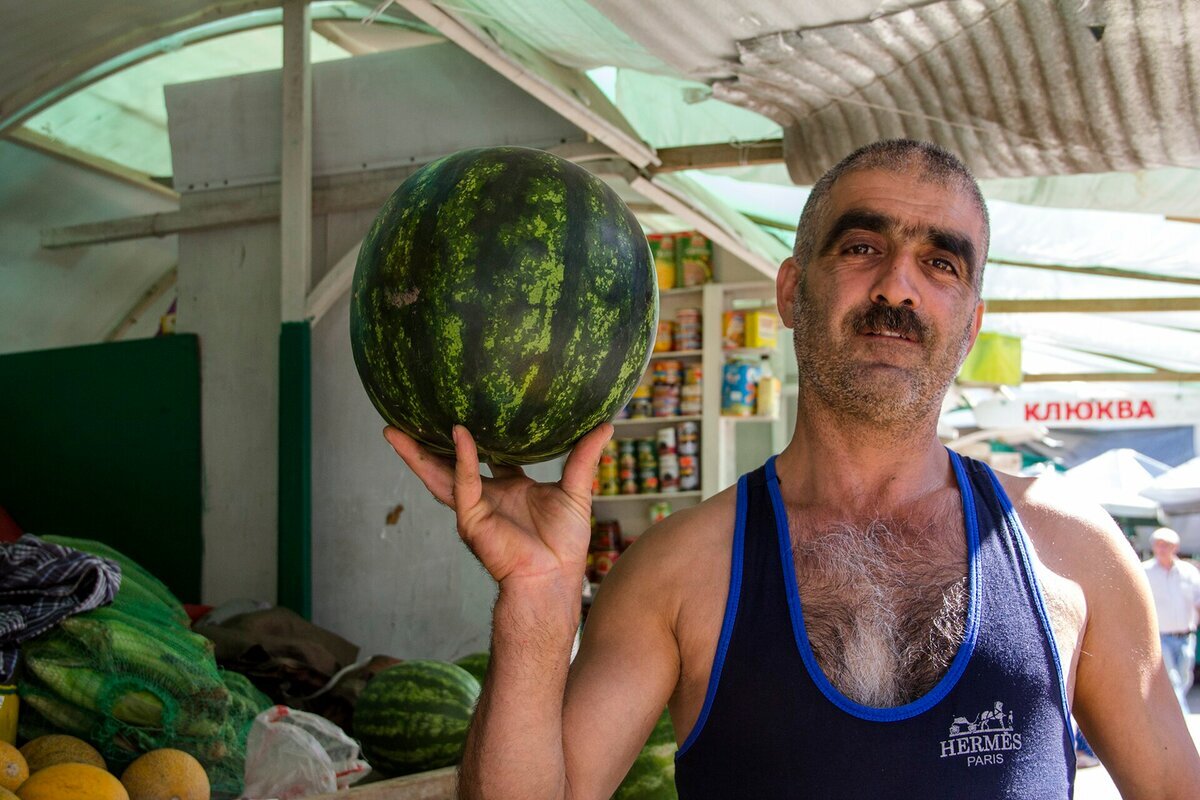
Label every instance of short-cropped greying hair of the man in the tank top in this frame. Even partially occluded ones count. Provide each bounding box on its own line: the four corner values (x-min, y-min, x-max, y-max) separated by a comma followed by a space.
792, 139, 991, 290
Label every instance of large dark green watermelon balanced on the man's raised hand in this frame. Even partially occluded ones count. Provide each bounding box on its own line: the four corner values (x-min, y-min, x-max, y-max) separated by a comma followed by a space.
350, 148, 658, 464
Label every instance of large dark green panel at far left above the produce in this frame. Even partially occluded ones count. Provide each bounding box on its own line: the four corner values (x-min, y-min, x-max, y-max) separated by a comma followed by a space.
0, 335, 204, 602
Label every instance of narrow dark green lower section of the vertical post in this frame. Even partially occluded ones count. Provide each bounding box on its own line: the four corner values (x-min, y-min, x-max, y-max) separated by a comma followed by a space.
277, 320, 312, 619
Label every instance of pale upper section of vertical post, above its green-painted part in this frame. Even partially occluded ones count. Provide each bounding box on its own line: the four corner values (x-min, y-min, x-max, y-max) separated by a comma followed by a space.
280, 0, 312, 323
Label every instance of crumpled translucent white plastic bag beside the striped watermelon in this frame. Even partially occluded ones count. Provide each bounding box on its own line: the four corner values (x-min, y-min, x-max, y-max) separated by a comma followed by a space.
242, 705, 371, 800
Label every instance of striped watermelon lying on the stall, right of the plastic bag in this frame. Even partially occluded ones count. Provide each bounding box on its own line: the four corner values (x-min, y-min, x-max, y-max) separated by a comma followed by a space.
354, 660, 480, 775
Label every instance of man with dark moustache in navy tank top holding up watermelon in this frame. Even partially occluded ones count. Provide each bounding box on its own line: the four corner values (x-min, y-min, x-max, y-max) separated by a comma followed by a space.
385, 140, 1200, 800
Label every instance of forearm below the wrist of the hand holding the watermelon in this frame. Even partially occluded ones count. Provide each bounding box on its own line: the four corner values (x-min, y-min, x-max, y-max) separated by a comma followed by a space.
458, 581, 580, 800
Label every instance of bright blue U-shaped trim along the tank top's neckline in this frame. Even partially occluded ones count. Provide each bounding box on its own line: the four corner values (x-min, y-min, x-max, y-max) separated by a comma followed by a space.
767, 450, 983, 722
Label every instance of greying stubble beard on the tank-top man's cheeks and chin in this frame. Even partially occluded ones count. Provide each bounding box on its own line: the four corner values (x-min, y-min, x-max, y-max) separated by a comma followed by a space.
792, 275, 972, 433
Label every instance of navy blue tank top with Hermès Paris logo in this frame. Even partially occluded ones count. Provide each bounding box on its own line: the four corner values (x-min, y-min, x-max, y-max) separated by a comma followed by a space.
676, 452, 1075, 800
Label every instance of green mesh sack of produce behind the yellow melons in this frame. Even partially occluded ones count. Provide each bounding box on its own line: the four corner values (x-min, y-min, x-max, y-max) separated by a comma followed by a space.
18, 536, 271, 795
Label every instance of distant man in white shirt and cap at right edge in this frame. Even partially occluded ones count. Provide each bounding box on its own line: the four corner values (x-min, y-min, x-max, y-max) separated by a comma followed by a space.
1141, 528, 1200, 714
